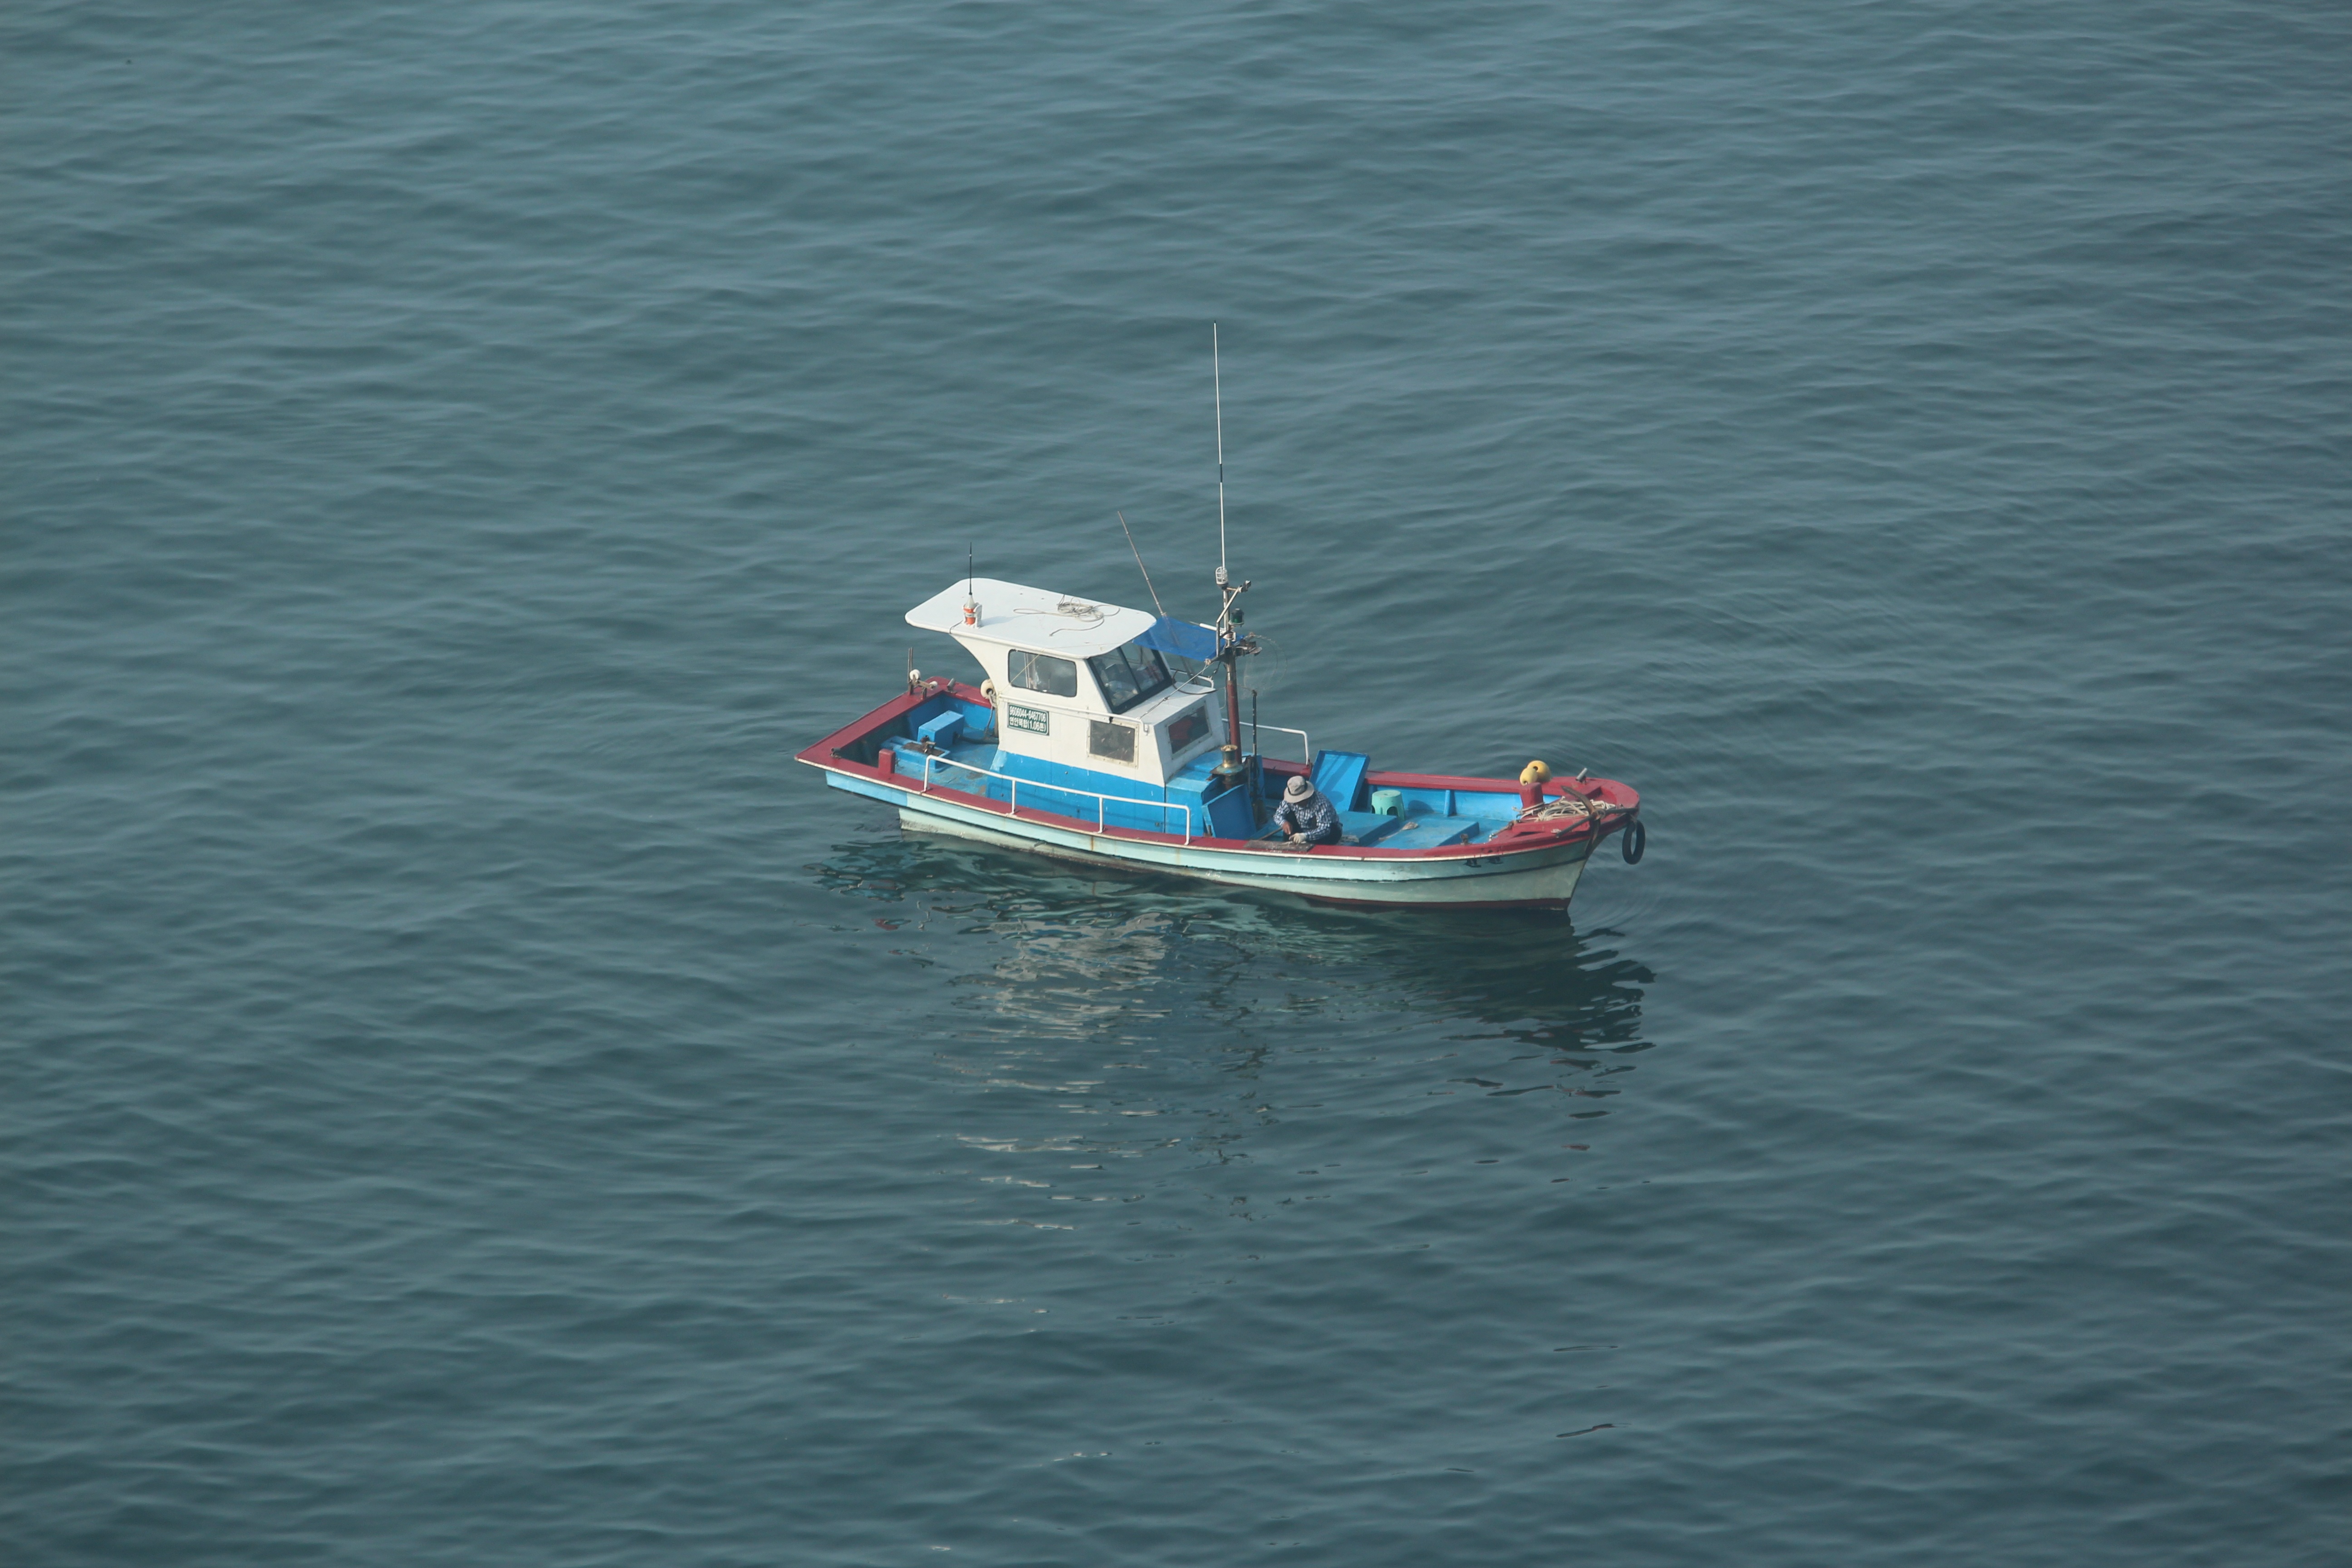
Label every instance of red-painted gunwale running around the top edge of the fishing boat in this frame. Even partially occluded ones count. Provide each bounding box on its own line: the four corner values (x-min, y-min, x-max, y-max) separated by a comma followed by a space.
793, 682, 1642, 860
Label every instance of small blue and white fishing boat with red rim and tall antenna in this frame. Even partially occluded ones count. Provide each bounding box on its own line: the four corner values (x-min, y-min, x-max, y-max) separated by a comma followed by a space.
797, 336, 1649, 910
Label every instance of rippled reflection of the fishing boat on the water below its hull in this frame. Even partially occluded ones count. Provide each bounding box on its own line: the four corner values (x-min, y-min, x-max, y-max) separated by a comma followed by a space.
818, 837, 1651, 1185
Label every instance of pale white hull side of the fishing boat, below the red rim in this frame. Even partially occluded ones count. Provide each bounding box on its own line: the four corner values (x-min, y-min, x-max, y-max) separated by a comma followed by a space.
884, 774, 1590, 907
